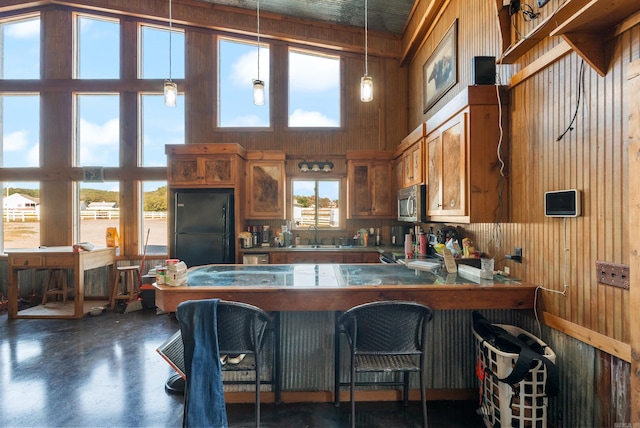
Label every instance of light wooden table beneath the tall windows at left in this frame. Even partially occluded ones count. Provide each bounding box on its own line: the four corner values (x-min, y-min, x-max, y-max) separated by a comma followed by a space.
6, 246, 116, 318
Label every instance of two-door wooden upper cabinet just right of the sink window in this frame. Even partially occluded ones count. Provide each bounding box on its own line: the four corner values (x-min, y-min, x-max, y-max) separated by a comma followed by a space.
347, 151, 395, 218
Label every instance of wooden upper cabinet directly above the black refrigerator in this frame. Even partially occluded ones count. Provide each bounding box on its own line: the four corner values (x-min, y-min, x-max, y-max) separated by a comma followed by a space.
165, 144, 245, 188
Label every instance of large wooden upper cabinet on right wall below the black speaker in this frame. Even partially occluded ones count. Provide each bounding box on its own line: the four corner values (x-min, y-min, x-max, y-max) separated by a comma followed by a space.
425, 85, 507, 223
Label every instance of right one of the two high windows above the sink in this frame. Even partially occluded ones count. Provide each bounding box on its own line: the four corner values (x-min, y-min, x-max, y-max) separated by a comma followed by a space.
289, 49, 340, 128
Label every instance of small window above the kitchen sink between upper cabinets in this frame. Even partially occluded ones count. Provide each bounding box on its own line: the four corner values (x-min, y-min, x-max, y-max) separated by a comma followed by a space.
291, 179, 342, 229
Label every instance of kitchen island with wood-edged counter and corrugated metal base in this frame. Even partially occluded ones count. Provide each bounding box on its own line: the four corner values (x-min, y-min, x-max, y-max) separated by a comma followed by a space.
154, 263, 536, 402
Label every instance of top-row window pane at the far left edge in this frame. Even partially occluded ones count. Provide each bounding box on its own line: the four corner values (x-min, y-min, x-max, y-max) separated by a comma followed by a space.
0, 16, 40, 80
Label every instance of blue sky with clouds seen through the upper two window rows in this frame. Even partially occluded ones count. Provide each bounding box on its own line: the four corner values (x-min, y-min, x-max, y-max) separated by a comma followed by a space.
1, 13, 340, 191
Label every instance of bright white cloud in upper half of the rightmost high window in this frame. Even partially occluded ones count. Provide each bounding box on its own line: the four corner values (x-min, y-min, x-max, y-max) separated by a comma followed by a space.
289, 52, 340, 92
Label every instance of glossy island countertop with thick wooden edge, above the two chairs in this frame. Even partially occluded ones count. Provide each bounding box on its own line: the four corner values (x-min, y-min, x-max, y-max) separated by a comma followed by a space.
154, 263, 536, 312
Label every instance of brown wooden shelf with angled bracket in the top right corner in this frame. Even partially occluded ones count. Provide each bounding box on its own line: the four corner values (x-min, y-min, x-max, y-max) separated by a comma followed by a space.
550, 0, 640, 76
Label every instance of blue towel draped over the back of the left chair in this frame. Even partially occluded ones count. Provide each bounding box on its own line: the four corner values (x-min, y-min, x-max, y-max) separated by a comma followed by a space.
176, 299, 228, 428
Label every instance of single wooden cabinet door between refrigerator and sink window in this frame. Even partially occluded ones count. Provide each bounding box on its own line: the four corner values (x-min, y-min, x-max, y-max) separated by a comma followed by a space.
247, 161, 285, 219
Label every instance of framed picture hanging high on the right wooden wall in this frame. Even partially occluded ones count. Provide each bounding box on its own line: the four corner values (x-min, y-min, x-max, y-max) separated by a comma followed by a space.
422, 20, 458, 113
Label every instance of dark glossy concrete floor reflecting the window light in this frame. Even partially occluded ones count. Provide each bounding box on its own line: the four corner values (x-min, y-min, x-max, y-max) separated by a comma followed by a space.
0, 309, 484, 428
